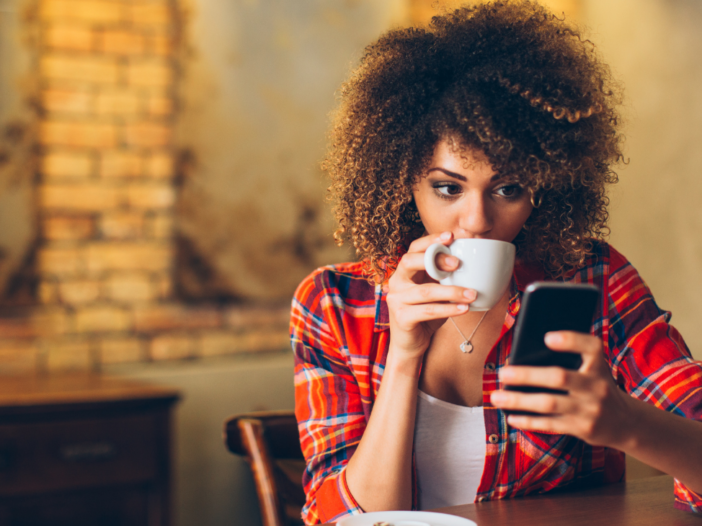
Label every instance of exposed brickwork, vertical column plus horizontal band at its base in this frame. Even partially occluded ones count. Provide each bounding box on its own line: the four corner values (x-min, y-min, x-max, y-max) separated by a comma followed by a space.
0, 0, 288, 372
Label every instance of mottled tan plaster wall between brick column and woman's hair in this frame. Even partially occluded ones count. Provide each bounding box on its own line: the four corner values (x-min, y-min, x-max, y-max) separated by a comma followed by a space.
178, 0, 405, 299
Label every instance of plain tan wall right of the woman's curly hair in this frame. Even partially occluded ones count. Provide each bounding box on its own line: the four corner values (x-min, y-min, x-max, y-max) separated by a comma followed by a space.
582, 0, 702, 359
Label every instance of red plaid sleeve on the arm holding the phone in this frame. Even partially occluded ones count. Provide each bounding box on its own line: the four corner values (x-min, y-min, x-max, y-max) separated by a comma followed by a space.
608, 249, 702, 513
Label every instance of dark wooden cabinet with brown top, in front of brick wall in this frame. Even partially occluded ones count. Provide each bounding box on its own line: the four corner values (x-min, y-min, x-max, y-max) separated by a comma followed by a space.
0, 375, 178, 526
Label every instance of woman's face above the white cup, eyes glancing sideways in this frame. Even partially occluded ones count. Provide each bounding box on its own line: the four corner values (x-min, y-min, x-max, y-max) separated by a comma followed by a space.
413, 140, 533, 242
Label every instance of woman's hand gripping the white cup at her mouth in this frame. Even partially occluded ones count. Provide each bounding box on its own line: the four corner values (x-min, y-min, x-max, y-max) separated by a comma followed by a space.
386, 232, 476, 359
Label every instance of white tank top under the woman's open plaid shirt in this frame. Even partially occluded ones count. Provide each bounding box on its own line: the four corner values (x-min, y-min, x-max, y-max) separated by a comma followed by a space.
414, 391, 486, 510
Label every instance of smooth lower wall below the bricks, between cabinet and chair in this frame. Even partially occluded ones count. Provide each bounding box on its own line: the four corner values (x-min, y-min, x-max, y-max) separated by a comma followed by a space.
108, 351, 294, 526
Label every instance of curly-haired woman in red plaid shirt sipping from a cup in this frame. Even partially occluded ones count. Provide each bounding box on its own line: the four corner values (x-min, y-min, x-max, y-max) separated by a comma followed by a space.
291, 1, 702, 524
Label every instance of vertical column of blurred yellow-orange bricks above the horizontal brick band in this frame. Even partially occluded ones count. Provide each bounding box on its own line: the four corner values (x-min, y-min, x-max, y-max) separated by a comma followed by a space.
37, 0, 178, 310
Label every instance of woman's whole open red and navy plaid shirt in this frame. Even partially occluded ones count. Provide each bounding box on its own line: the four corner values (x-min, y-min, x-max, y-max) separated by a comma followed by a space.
291, 243, 702, 524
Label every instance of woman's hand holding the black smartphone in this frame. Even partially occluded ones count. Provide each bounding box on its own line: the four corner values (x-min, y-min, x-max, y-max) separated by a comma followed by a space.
490, 331, 633, 447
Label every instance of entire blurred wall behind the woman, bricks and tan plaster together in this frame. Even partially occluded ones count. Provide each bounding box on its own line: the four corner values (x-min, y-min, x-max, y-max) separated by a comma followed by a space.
0, 0, 702, 526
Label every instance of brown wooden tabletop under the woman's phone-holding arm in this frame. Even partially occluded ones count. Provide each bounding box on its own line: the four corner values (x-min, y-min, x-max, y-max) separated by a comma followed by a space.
324, 476, 702, 526
